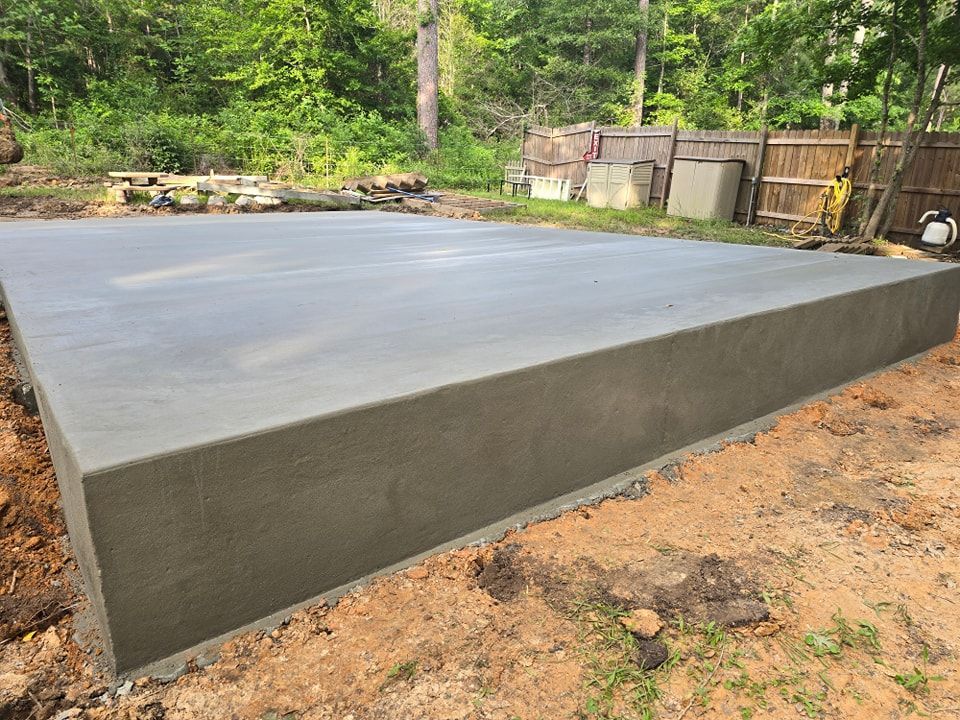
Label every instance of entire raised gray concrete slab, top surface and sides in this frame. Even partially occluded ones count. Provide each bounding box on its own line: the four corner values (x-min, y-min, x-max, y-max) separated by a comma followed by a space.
0, 212, 960, 671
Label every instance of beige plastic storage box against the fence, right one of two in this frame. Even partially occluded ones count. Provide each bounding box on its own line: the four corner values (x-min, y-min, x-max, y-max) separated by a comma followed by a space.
667, 157, 744, 220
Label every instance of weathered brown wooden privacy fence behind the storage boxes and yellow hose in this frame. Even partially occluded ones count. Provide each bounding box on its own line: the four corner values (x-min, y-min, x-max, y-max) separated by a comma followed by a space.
523, 123, 960, 242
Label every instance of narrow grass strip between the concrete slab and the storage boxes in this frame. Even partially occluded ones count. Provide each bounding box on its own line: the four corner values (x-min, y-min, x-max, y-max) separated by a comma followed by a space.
470, 192, 792, 247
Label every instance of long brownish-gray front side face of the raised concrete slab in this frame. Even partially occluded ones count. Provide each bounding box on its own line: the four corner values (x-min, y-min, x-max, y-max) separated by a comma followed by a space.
75, 272, 960, 670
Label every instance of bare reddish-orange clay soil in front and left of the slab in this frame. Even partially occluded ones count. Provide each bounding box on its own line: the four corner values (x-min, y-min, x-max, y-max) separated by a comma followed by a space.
0, 310, 960, 720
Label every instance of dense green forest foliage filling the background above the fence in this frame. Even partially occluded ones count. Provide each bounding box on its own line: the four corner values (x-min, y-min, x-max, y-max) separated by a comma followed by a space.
0, 0, 960, 187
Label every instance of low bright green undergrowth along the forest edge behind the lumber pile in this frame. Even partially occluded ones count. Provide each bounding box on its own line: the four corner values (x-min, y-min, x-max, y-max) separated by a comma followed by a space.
15, 91, 516, 188
